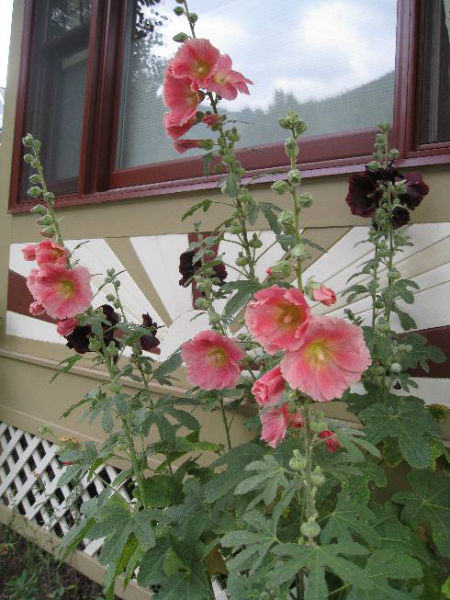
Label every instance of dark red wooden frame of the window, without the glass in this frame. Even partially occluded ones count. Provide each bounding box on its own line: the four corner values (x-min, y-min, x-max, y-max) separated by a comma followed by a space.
9, 0, 450, 213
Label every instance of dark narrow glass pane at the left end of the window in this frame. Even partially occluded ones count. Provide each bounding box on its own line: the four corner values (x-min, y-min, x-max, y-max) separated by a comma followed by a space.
24, 0, 90, 193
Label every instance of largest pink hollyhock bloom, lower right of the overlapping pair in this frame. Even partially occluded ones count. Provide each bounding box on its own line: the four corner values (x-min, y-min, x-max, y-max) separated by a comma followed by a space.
281, 317, 371, 402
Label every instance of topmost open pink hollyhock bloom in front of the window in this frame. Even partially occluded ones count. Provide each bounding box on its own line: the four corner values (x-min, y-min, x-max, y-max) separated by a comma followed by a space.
171, 39, 220, 88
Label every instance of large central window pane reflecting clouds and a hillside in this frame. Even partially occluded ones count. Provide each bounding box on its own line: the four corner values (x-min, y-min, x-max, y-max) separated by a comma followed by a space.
117, 0, 397, 168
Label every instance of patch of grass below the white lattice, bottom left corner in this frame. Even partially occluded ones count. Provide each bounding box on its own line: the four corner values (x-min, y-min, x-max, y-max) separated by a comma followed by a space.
0, 524, 118, 600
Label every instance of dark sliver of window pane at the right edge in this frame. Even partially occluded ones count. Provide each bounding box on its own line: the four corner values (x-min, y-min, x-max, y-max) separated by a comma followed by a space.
420, 0, 450, 144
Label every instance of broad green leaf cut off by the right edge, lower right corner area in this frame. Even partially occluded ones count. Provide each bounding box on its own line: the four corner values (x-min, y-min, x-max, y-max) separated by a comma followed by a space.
392, 471, 450, 557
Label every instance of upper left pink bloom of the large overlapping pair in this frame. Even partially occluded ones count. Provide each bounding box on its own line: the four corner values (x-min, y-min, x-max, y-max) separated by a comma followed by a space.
245, 285, 310, 354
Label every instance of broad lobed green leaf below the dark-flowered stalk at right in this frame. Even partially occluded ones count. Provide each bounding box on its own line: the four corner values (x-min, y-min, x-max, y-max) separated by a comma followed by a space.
359, 396, 440, 469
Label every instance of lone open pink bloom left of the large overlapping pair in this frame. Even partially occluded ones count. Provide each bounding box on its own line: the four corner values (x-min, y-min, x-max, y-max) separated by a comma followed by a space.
181, 330, 244, 390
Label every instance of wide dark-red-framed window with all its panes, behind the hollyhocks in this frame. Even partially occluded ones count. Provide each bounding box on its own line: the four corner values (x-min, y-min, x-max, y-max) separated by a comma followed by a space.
7, 0, 450, 210
